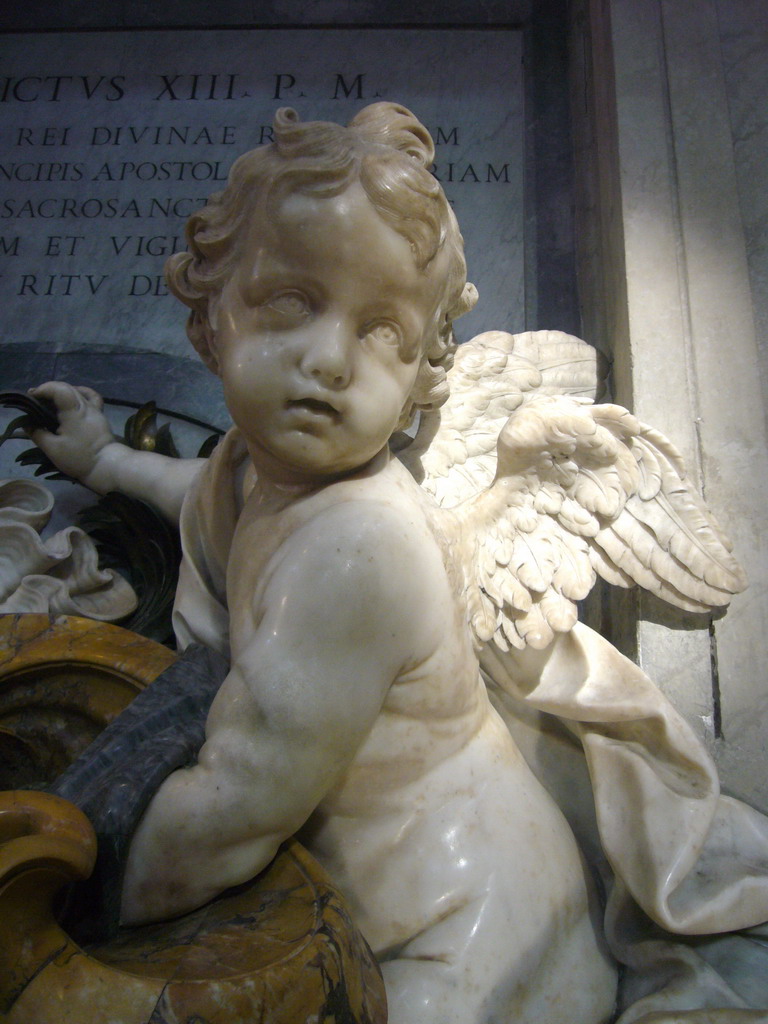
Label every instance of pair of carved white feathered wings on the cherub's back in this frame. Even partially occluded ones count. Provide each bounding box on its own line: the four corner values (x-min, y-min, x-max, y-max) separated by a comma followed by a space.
399, 332, 745, 649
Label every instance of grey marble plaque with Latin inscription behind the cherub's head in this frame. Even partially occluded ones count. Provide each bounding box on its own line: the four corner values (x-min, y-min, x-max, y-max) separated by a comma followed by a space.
0, 30, 524, 356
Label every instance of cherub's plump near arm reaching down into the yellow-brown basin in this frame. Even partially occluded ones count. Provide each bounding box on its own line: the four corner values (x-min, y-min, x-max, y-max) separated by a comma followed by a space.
122, 503, 438, 924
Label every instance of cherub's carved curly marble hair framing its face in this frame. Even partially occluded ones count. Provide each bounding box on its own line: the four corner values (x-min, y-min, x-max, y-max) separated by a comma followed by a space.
165, 103, 477, 409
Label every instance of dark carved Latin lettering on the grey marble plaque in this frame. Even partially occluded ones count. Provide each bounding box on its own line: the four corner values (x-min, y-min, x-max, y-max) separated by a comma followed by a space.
0, 106, 510, 298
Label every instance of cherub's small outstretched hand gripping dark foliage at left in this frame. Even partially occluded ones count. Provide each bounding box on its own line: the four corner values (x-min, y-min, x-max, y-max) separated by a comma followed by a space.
30, 381, 115, 490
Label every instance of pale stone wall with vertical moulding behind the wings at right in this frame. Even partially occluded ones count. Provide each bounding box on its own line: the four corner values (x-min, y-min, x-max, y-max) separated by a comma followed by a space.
572, 0, 768, 809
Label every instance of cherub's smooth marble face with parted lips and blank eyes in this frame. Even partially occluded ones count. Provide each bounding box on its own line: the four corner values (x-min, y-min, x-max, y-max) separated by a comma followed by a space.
212, 183, 442, 482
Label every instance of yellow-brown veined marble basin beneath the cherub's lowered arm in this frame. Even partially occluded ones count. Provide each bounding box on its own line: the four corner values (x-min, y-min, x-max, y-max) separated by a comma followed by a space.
0, 615, 386, 1024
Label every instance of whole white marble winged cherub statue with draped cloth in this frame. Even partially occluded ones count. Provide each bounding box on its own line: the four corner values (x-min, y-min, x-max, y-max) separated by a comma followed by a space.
28, 103, 768, 1024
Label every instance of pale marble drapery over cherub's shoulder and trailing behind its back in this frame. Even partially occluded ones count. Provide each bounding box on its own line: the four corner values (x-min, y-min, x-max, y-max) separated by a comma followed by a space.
174, 429, 768, 1024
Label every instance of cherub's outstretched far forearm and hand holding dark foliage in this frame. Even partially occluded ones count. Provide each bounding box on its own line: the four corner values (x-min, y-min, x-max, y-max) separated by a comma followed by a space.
32, 381, 204, 522
